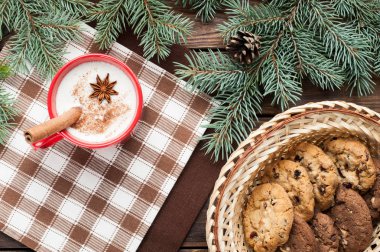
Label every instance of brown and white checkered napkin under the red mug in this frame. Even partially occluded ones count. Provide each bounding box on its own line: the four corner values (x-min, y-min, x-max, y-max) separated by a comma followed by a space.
0, 26, 211, 251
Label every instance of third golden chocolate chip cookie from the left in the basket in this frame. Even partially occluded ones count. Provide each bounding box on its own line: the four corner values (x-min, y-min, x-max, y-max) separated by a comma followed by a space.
290, 142, 339, 211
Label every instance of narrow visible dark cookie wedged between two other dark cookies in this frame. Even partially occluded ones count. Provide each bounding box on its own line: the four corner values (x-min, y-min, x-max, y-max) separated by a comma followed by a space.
312, 212, 339, 252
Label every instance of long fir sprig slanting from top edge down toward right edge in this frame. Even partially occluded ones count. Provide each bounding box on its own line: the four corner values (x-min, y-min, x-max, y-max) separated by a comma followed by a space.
305, 1, 375, 95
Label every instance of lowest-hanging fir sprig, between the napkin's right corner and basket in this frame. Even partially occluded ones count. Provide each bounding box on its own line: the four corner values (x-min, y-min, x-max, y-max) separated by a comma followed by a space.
202, 82, 262, 161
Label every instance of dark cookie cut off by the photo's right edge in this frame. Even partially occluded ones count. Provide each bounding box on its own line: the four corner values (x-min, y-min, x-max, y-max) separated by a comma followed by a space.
364, 159, 380, 222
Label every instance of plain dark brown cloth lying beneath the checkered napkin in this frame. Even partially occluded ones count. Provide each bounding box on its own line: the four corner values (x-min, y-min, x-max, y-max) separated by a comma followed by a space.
113, 30, 224, 252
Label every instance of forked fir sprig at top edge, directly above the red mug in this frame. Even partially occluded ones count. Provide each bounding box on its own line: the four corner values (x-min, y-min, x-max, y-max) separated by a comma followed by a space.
90, 0, 192, 59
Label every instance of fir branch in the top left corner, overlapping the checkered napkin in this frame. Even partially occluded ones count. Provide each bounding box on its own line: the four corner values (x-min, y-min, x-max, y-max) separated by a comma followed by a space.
0, 0, 84, 77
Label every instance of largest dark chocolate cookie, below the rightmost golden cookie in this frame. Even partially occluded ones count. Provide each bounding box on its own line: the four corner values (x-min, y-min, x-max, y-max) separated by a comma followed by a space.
331, 185, 373, 252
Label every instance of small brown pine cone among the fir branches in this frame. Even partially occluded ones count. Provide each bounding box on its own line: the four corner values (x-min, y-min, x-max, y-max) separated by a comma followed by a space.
226, 31, 261, 64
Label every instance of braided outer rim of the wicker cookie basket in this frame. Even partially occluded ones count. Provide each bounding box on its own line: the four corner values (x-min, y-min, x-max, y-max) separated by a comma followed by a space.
206, 101, 380, 252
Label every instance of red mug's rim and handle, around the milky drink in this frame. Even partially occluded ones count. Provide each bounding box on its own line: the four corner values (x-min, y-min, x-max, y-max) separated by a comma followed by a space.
33, 53, 143, 149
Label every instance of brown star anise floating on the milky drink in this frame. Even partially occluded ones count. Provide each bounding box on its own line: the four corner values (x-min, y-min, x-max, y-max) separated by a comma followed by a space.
90, 73, 119, 104
